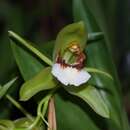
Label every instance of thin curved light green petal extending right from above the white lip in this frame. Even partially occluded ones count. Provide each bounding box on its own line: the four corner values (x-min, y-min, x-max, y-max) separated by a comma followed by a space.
85, 67, 113, 80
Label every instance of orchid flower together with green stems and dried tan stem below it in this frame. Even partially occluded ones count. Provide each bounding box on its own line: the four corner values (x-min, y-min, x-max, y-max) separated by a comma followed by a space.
1, 21, 113, 130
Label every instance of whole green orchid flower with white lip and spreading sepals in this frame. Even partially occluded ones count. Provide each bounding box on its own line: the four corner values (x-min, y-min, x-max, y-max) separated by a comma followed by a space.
9, 21, 113, 122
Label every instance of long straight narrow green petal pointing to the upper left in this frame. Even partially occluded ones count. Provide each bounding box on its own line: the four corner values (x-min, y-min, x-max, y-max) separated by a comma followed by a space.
8, 31, 53, 66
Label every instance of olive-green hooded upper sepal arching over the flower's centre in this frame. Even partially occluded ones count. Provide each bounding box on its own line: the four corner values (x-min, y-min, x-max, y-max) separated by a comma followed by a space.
53, 21, 87, 60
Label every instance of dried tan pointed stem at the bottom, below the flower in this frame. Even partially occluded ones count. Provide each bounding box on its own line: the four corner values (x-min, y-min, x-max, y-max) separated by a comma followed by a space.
48, 97, 57, 130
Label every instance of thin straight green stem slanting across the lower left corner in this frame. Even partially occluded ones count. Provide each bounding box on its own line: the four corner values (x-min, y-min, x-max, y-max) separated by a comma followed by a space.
6, 94, 33, 120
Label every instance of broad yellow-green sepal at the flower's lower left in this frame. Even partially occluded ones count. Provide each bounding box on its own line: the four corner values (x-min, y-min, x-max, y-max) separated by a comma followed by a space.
20, 67, 57, 101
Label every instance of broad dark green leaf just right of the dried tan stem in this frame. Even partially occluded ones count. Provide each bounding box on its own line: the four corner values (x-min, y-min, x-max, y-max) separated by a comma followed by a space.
55, 89, 99, 130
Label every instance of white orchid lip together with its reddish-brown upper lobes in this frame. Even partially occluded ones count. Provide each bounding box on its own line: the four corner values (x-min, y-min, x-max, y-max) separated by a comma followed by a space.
52, 45, 91, 86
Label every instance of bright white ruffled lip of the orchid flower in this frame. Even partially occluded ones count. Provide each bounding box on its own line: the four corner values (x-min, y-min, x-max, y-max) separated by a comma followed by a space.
52, 63, 91, 86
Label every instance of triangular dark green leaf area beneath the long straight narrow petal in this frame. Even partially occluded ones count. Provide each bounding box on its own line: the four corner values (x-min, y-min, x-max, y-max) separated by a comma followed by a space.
11, 38, 44, 80
